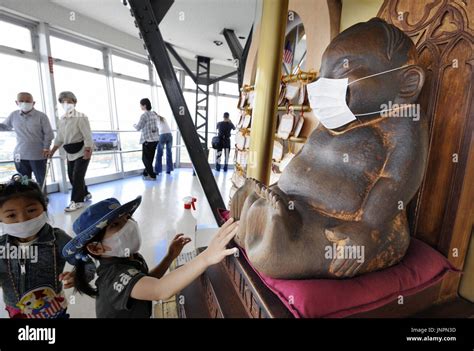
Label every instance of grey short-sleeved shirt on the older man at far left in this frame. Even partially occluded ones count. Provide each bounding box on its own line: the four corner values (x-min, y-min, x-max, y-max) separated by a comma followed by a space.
0, 109, 54, 160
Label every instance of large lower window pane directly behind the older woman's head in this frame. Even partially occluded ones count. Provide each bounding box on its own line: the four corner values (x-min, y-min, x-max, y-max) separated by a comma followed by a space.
54, 65, 111, 130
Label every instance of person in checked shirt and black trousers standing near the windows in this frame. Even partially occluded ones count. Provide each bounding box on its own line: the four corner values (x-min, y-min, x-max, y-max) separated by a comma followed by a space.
134, 98, 159, 180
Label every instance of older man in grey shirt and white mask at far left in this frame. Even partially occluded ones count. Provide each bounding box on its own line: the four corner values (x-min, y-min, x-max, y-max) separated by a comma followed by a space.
0, 92, 54, 186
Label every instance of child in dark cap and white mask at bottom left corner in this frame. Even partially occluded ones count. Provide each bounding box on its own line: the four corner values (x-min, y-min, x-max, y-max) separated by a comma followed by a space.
0, 175, 83, 318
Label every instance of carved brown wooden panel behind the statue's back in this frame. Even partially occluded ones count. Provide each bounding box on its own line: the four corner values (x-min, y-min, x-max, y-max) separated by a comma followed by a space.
378, 0, 474, 298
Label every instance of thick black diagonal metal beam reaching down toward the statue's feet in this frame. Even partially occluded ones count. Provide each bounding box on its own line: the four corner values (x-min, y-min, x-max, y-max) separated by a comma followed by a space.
129, 0, 225, 224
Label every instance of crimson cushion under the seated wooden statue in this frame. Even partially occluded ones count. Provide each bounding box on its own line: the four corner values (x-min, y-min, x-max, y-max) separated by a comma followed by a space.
242, 238, 456, 318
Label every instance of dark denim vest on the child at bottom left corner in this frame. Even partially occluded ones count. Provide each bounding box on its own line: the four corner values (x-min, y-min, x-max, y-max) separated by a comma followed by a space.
0, 224, 71, 306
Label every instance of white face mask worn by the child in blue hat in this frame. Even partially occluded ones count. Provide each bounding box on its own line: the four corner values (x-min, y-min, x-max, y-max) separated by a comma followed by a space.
102, 219, 142, 257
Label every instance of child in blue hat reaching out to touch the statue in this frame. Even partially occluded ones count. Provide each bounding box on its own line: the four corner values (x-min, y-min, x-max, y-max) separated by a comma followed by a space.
63, 196, 237, 318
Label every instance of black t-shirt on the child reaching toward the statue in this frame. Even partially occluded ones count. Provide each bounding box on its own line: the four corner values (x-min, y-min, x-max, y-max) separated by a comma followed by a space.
95, 254, 152, 318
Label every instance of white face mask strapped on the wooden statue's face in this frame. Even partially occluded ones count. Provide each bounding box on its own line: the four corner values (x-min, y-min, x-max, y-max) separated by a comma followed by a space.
307, 65, 407, 129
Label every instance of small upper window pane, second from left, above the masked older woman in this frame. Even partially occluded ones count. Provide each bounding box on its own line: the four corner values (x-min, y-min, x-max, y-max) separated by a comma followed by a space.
50, 36, 104, 68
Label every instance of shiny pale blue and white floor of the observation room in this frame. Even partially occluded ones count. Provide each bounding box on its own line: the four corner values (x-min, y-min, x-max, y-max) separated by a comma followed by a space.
0, 169, 232, 318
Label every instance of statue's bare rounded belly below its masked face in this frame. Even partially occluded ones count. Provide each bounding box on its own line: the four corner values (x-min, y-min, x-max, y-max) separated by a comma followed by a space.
278, 127, 387, 219
